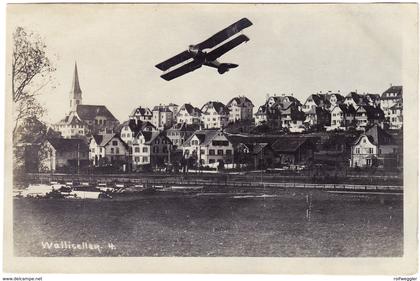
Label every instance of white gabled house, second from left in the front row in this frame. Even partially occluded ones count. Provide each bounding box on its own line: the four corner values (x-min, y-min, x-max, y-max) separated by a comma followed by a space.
89, 134, 129, 166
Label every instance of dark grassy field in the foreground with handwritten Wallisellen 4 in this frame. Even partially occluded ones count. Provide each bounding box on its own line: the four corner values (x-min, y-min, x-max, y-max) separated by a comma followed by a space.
14, 190, 403, 257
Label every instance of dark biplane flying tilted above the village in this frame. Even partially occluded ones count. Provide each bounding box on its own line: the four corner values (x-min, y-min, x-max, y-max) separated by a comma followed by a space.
156, 18, 252, 81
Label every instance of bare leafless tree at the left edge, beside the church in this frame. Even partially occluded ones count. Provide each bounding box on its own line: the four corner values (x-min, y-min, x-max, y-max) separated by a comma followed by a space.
12, 27, 55, 134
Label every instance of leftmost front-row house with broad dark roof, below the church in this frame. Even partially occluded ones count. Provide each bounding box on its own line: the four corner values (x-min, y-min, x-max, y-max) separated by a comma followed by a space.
38, 138, 89, 172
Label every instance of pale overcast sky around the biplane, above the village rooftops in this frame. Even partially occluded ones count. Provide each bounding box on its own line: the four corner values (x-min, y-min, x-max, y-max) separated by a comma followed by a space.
8, 4, 416, 122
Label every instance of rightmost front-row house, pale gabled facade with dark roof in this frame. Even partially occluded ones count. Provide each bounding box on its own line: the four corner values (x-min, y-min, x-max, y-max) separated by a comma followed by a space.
350, 124, 398, 168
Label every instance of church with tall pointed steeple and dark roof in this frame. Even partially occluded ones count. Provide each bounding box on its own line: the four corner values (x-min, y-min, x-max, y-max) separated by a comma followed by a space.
53, 63, 119, 138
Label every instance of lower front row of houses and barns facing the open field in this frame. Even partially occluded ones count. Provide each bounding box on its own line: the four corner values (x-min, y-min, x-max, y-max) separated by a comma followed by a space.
41, 122, 403, 171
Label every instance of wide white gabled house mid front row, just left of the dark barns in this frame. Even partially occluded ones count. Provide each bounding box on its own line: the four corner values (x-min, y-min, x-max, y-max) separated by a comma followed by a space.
182, 129, 234, 166
